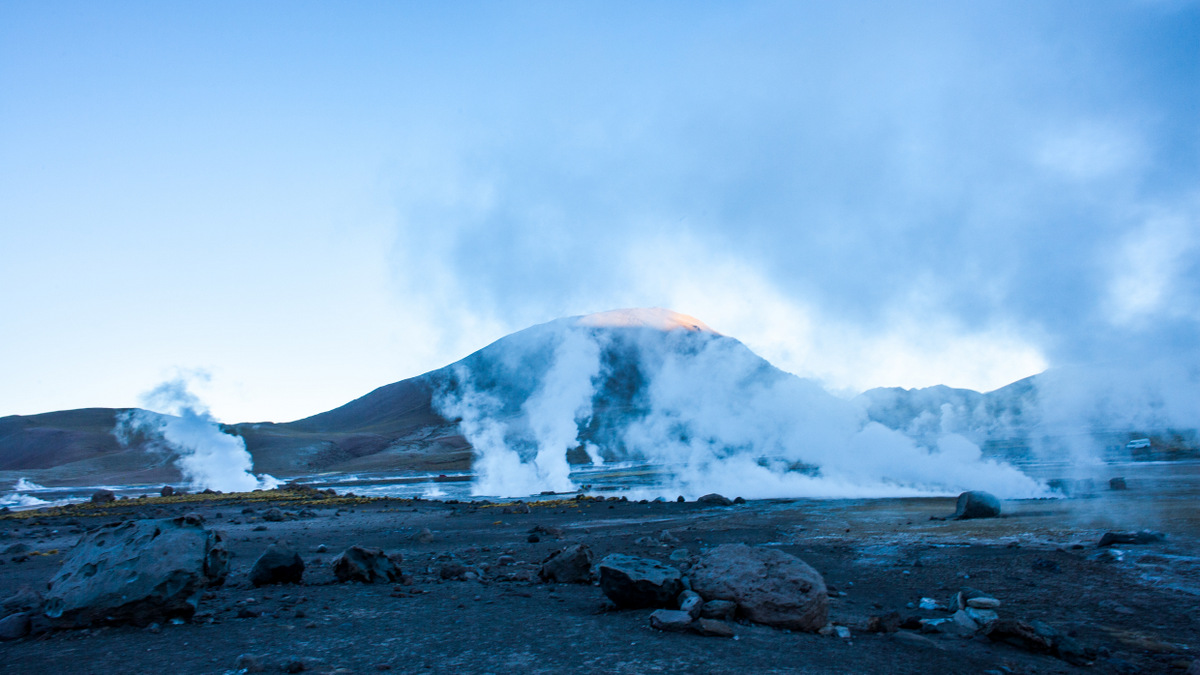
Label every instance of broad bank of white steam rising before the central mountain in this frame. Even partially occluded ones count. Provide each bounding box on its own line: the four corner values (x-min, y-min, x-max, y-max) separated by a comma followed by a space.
434, 315, 1045, 498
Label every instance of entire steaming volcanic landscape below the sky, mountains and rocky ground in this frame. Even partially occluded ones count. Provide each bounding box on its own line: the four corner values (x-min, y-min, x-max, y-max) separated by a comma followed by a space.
0, 310, 1200, 674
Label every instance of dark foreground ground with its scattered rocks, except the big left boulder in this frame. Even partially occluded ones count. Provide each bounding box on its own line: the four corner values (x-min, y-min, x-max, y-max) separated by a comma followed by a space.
0, 482, 1200, 674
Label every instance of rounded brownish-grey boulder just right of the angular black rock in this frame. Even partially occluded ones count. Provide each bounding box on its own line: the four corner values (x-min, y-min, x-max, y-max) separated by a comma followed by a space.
689, 544, 829, 632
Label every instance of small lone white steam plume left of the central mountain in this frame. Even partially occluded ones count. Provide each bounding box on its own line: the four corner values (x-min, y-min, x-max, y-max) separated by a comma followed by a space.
113, 377, 278, 492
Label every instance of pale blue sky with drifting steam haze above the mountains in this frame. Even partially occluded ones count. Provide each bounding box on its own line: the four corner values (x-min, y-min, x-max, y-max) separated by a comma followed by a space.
0, 0, 1200, 422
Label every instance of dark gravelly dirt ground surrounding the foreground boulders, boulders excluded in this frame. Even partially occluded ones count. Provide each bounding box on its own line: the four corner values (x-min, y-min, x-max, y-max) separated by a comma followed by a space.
0, 489, 1200, 675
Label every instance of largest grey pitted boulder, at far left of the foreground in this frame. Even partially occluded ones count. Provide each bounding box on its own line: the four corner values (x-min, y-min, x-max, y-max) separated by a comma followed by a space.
43, 518, 229, 627
